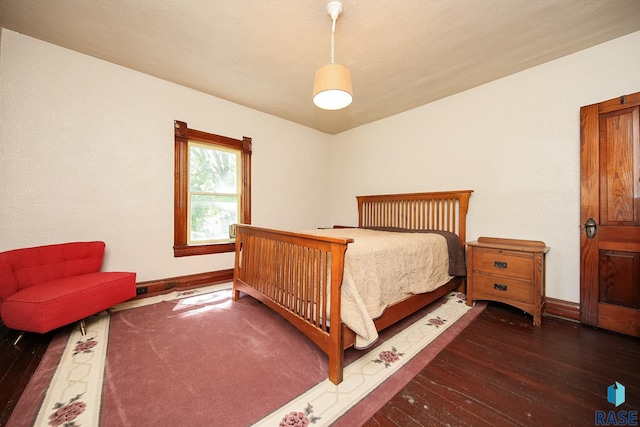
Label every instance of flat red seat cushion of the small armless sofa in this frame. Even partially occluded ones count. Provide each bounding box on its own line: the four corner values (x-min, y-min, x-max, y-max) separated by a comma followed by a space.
0, 272, 136, 333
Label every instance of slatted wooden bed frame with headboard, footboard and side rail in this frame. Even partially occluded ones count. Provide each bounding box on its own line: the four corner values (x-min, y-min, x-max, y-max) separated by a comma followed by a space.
233, 190, 472, 384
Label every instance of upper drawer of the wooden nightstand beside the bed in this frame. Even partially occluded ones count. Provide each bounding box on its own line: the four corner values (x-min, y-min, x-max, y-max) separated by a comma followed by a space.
473, 248, 534, 280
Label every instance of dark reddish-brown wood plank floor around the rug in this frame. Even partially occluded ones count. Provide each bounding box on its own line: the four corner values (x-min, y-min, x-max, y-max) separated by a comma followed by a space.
0, 303, 640, 427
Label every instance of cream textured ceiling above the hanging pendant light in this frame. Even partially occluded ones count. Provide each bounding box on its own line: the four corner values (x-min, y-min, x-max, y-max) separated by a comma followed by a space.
0, 0, 640, 134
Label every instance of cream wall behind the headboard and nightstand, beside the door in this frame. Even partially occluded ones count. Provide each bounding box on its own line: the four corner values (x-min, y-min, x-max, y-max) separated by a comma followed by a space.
332, 32, 640, 302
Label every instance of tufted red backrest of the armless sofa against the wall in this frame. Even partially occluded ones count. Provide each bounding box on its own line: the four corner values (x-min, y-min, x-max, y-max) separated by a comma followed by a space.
0, 242, 105, 300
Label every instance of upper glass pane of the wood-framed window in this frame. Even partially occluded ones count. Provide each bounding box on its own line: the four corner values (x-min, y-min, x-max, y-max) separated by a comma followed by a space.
189, 144, 238, 194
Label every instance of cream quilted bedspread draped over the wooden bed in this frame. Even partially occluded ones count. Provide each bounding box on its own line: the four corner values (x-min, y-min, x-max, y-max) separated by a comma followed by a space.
304, 228, 452, 349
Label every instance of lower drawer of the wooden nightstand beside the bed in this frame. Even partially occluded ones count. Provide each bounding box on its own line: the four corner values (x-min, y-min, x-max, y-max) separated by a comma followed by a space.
473, 273, 534, 304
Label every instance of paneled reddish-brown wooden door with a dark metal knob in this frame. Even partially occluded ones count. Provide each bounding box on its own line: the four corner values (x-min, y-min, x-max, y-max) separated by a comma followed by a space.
580, 93, 640, 336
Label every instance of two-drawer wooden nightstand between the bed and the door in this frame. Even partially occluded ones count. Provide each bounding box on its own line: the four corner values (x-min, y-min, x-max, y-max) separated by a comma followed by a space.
467, 237, 549, 325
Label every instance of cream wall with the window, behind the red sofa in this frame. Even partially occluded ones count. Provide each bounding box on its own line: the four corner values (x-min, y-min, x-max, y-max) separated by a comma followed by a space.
0, 30, 331, 281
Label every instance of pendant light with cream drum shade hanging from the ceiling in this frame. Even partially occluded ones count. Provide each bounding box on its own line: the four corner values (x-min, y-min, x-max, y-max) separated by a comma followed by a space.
313, 1, 353, 110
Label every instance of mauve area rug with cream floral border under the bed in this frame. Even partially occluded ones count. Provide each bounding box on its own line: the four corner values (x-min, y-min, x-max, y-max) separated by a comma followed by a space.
8, 284, 483, 427
